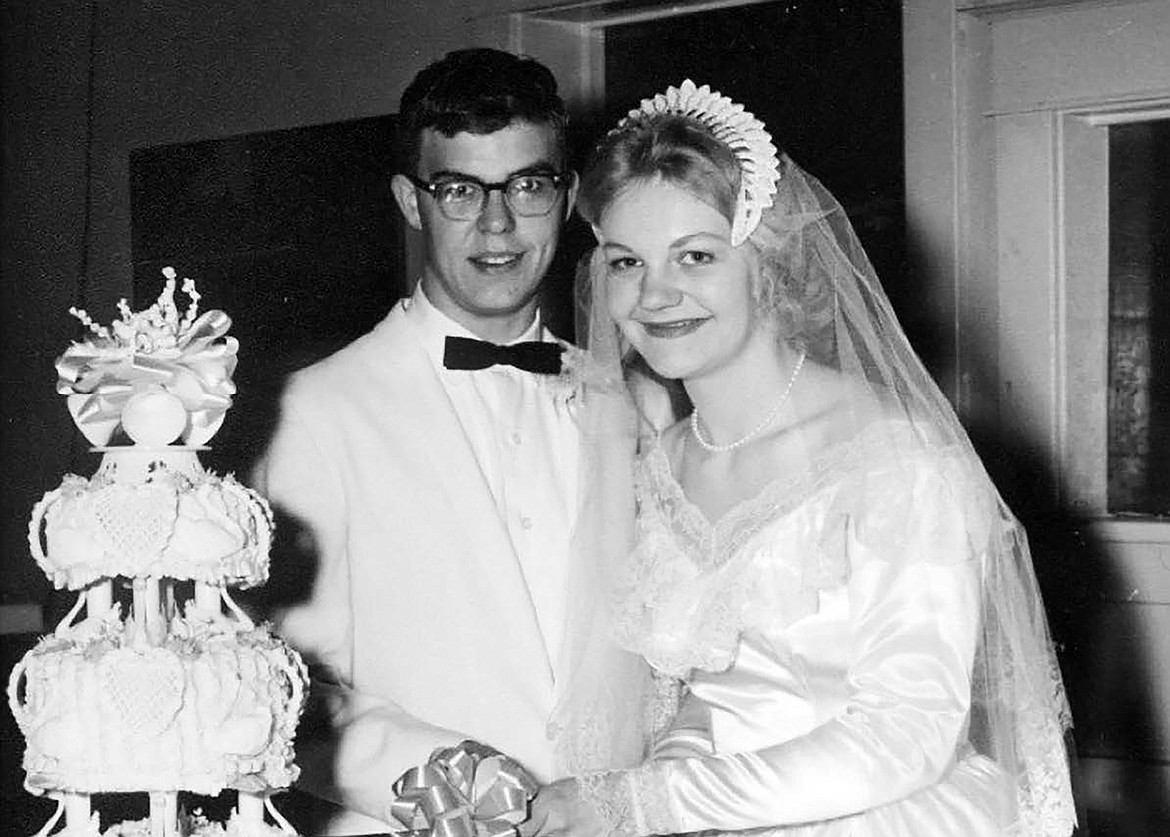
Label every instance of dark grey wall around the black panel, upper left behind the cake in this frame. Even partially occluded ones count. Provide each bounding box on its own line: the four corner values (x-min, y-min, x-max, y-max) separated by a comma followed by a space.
0, 0, 535, 605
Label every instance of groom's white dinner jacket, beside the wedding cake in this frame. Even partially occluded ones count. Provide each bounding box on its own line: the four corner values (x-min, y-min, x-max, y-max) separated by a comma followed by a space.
257, 302, 570, 833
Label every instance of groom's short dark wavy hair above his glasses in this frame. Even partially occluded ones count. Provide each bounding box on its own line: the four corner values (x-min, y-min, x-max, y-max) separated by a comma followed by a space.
398, 48, 569, 174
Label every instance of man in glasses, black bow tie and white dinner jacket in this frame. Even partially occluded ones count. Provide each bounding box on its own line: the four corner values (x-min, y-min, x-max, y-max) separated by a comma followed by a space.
257, 49, 603, 833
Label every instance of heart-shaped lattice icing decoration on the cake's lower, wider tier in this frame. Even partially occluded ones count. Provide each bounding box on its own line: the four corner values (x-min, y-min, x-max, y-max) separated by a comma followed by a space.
98, 649, 184, 736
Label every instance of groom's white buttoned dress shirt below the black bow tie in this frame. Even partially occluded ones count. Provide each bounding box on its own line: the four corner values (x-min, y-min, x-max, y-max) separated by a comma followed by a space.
406, 283, 579, 672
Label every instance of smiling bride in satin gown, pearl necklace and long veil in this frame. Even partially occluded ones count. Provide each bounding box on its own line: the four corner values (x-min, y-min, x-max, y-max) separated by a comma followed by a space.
519, 82, 1075, 837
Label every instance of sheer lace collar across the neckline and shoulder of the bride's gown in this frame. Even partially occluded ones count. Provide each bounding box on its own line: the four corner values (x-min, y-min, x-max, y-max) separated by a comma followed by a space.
617, 424, 993, 677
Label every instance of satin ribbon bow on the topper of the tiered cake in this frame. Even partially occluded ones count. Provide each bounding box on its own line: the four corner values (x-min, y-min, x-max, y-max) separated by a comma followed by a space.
56, 311, 239, 445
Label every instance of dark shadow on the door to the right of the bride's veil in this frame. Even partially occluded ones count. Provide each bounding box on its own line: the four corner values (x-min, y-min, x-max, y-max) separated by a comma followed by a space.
932, 299, 1170, 837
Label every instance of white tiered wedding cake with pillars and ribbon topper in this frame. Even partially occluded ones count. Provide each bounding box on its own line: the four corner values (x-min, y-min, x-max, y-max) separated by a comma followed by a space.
8, 268, 308, 837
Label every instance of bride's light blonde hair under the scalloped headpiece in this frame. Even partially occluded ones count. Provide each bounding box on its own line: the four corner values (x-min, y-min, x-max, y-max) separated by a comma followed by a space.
577, 114, 832, 361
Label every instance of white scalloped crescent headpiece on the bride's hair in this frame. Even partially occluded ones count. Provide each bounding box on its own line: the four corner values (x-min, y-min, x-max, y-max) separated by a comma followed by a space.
615, 78, 780, 246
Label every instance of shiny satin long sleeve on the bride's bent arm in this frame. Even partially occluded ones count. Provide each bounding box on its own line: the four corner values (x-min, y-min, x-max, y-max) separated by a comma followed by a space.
583, 461, 980, 835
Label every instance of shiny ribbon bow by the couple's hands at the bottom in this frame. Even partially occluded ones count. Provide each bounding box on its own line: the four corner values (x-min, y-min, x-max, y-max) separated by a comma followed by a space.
390, 741, 538, 837
